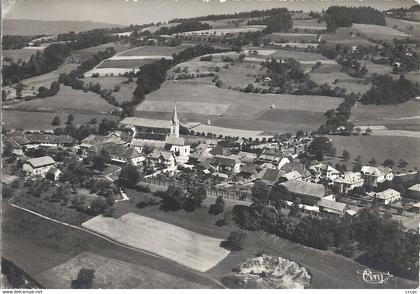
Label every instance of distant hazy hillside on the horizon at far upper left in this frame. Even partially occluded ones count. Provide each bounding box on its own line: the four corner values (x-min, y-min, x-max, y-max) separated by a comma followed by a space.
3, 19, 121, 36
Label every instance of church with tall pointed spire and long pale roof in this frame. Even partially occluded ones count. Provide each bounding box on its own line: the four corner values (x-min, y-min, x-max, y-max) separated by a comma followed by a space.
120, 104, 190, 162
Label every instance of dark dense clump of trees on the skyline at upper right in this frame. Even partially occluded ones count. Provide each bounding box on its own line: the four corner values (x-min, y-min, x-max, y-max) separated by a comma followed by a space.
324, 6, 386, 32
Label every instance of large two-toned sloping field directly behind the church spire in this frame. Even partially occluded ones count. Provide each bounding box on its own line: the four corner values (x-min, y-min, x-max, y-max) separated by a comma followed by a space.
137, 78, 342, 132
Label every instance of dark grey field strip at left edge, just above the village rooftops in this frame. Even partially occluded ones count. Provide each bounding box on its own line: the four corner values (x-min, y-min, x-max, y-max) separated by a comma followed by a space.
2, 109, 119, 130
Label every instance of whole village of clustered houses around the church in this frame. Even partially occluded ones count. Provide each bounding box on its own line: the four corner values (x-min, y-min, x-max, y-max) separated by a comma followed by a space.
6, 106, 420, 215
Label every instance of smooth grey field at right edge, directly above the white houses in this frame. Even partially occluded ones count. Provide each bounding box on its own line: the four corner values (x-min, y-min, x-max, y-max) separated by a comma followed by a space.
331, 136, 420, 171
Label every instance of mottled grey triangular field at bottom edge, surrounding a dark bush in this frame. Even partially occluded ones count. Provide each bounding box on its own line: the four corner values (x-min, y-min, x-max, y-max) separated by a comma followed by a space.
40, 251, 204, 289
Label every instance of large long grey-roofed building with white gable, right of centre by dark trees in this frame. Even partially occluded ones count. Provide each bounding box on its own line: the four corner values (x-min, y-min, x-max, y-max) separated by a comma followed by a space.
282, 180, 335, 206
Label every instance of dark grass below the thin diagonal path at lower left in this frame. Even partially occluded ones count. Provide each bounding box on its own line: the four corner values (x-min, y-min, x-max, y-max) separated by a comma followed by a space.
2, 202, 219, 288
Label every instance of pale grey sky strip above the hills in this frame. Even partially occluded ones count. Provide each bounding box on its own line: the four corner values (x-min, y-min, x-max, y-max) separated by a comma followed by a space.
3, 0, 415, 24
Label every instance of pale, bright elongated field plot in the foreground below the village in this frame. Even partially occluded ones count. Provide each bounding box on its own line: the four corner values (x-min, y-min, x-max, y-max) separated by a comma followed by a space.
82, 213, 229, 272
